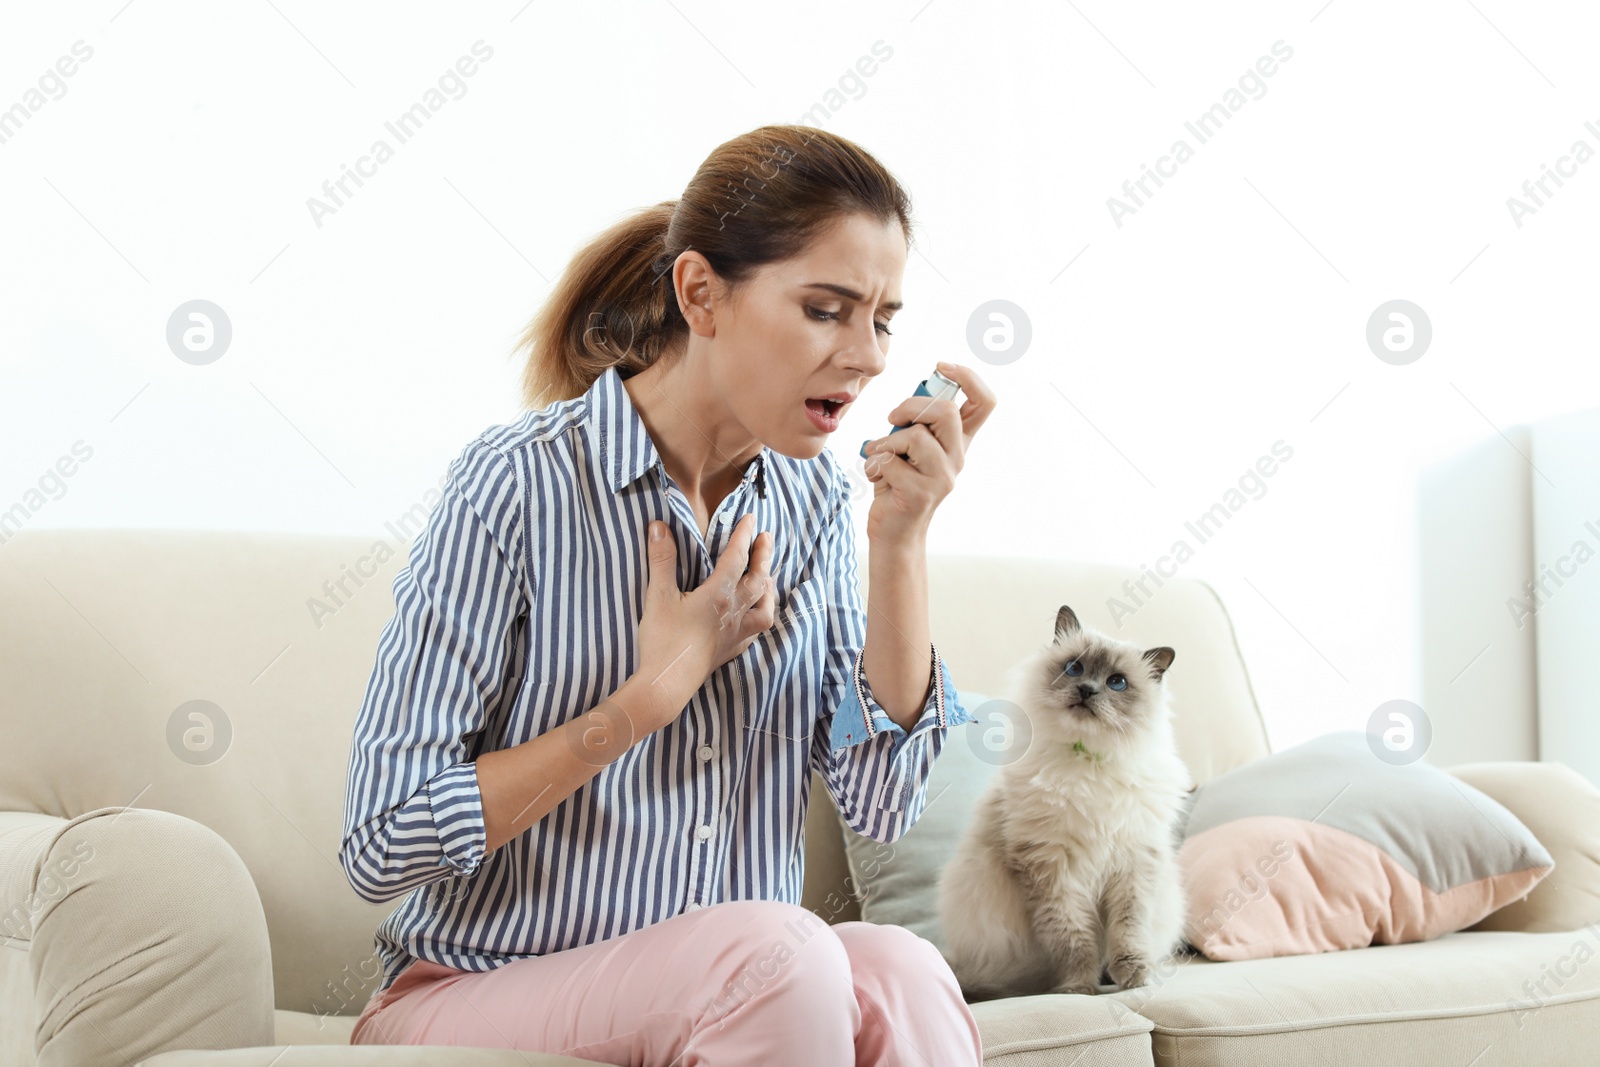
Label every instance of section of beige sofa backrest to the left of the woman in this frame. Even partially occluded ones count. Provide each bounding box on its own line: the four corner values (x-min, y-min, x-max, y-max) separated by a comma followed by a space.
0, 528, 410, 1014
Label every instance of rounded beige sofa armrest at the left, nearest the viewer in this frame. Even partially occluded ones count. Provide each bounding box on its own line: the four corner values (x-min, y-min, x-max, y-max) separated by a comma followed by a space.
0, 806, 274, 1067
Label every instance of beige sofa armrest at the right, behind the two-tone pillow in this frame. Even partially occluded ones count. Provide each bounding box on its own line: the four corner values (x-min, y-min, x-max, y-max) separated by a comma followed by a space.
1443, 760, 1600, 933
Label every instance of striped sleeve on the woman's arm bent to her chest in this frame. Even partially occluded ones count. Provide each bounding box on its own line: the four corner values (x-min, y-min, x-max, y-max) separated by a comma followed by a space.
339, 437, 531, 904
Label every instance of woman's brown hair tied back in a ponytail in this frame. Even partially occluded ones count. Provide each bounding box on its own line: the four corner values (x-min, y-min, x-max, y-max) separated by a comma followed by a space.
515, 126, 912, 408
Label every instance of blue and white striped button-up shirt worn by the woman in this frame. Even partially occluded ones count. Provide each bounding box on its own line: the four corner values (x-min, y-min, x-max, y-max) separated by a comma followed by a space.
339, 368, 973, 989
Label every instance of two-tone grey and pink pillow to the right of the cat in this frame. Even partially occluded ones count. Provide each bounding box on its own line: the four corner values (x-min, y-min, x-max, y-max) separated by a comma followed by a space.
1179, 729, 1554, 960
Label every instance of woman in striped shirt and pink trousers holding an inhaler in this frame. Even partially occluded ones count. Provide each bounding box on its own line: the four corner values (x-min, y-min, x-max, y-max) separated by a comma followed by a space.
341, 126, 995, 1067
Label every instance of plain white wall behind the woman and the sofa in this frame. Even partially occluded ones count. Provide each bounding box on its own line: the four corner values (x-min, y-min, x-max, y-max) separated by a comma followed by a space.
0, 0, 1600, 758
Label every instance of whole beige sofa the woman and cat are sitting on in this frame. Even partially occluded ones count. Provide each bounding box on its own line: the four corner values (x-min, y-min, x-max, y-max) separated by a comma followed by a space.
0, 530, 1600, 1067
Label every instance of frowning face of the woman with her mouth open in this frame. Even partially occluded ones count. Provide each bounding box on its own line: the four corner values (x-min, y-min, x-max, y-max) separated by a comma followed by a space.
709, 214, 906, 459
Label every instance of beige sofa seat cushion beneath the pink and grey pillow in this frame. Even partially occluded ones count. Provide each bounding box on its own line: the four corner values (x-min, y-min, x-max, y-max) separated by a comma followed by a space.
1104, 926, 1600, 1067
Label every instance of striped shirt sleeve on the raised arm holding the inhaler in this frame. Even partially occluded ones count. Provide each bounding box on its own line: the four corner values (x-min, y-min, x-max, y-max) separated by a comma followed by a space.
811, 477, 974, 841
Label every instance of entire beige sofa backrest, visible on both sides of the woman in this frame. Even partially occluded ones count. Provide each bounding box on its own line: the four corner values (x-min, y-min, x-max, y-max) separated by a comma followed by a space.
0, 528, 1267, 1014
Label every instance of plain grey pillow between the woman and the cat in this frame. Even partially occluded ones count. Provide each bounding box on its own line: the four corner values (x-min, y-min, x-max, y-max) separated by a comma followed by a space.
838, 688, 1010, 955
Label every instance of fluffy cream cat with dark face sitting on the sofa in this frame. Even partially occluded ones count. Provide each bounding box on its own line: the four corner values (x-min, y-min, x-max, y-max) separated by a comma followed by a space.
938, 605, 1194, 1000
